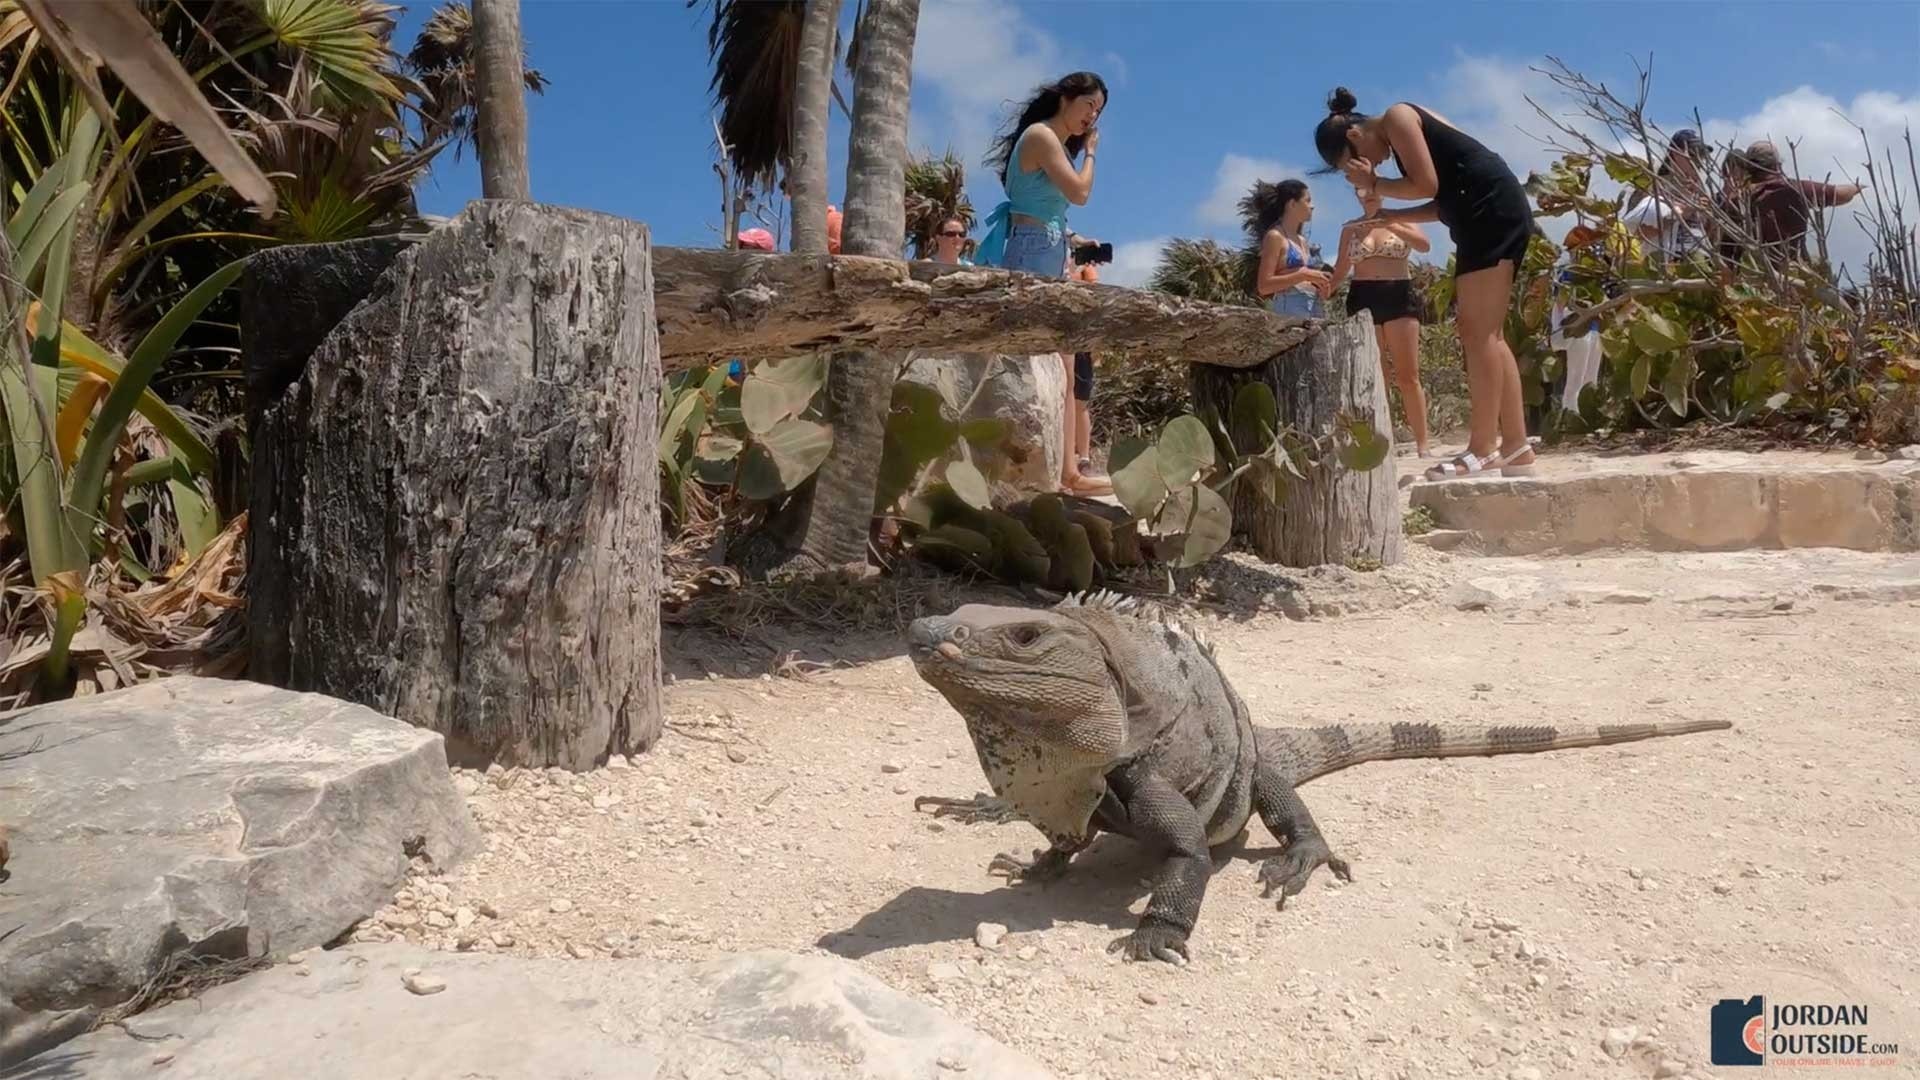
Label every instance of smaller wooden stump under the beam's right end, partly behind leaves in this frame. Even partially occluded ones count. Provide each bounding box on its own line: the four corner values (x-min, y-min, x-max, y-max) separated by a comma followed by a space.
1192, 315, 1404, 567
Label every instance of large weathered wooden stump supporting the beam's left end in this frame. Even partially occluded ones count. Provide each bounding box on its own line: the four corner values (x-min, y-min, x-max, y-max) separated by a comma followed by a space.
248, 202, 660, 769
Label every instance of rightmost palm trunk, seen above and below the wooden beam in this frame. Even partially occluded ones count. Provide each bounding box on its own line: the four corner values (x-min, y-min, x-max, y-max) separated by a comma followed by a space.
743, 0, 920, 573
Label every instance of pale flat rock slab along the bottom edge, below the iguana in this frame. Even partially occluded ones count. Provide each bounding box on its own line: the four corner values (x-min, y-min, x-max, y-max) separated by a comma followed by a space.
4, 945, 1048, 1080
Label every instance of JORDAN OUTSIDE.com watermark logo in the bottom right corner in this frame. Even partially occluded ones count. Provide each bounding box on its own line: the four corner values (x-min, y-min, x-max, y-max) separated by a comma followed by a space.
1709, 994, 1899, 1067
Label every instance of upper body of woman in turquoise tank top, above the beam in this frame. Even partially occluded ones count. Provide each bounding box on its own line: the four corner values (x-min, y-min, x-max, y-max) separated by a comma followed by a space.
973, 71, 1106, 277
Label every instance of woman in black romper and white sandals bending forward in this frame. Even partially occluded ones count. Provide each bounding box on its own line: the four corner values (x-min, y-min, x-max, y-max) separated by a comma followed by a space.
1313, 86, 1538, 480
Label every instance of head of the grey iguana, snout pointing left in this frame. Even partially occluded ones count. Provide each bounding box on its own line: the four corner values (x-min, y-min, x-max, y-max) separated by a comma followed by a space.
906, 603, 1127, 759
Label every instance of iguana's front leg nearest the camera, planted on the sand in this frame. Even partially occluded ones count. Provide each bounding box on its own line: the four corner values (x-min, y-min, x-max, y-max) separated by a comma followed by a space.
1102, 765, 1213, 965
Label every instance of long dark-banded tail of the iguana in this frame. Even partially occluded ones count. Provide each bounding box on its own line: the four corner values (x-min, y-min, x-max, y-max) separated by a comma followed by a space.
1256, 721, 1734, 786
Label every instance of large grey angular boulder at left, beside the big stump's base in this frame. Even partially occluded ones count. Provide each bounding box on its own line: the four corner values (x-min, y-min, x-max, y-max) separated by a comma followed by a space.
0, 676, 478, 1067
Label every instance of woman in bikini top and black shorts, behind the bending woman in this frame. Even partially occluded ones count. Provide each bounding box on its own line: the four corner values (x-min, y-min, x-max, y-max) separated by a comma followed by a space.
1321, 190, 1432, 457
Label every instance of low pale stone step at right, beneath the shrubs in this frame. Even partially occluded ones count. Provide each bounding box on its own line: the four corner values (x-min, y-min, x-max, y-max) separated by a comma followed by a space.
1405, 452, 1920, 555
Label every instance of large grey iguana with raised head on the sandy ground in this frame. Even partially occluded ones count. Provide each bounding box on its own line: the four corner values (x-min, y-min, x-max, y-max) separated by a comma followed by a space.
906, 592, 1732, 963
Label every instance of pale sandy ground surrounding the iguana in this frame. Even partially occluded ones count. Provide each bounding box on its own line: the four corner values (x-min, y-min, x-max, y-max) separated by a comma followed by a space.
353, 553, 1920, 1080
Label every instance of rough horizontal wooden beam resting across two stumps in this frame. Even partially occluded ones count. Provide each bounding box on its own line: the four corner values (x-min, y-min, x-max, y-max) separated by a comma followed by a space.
653, 248, 1319, 371
